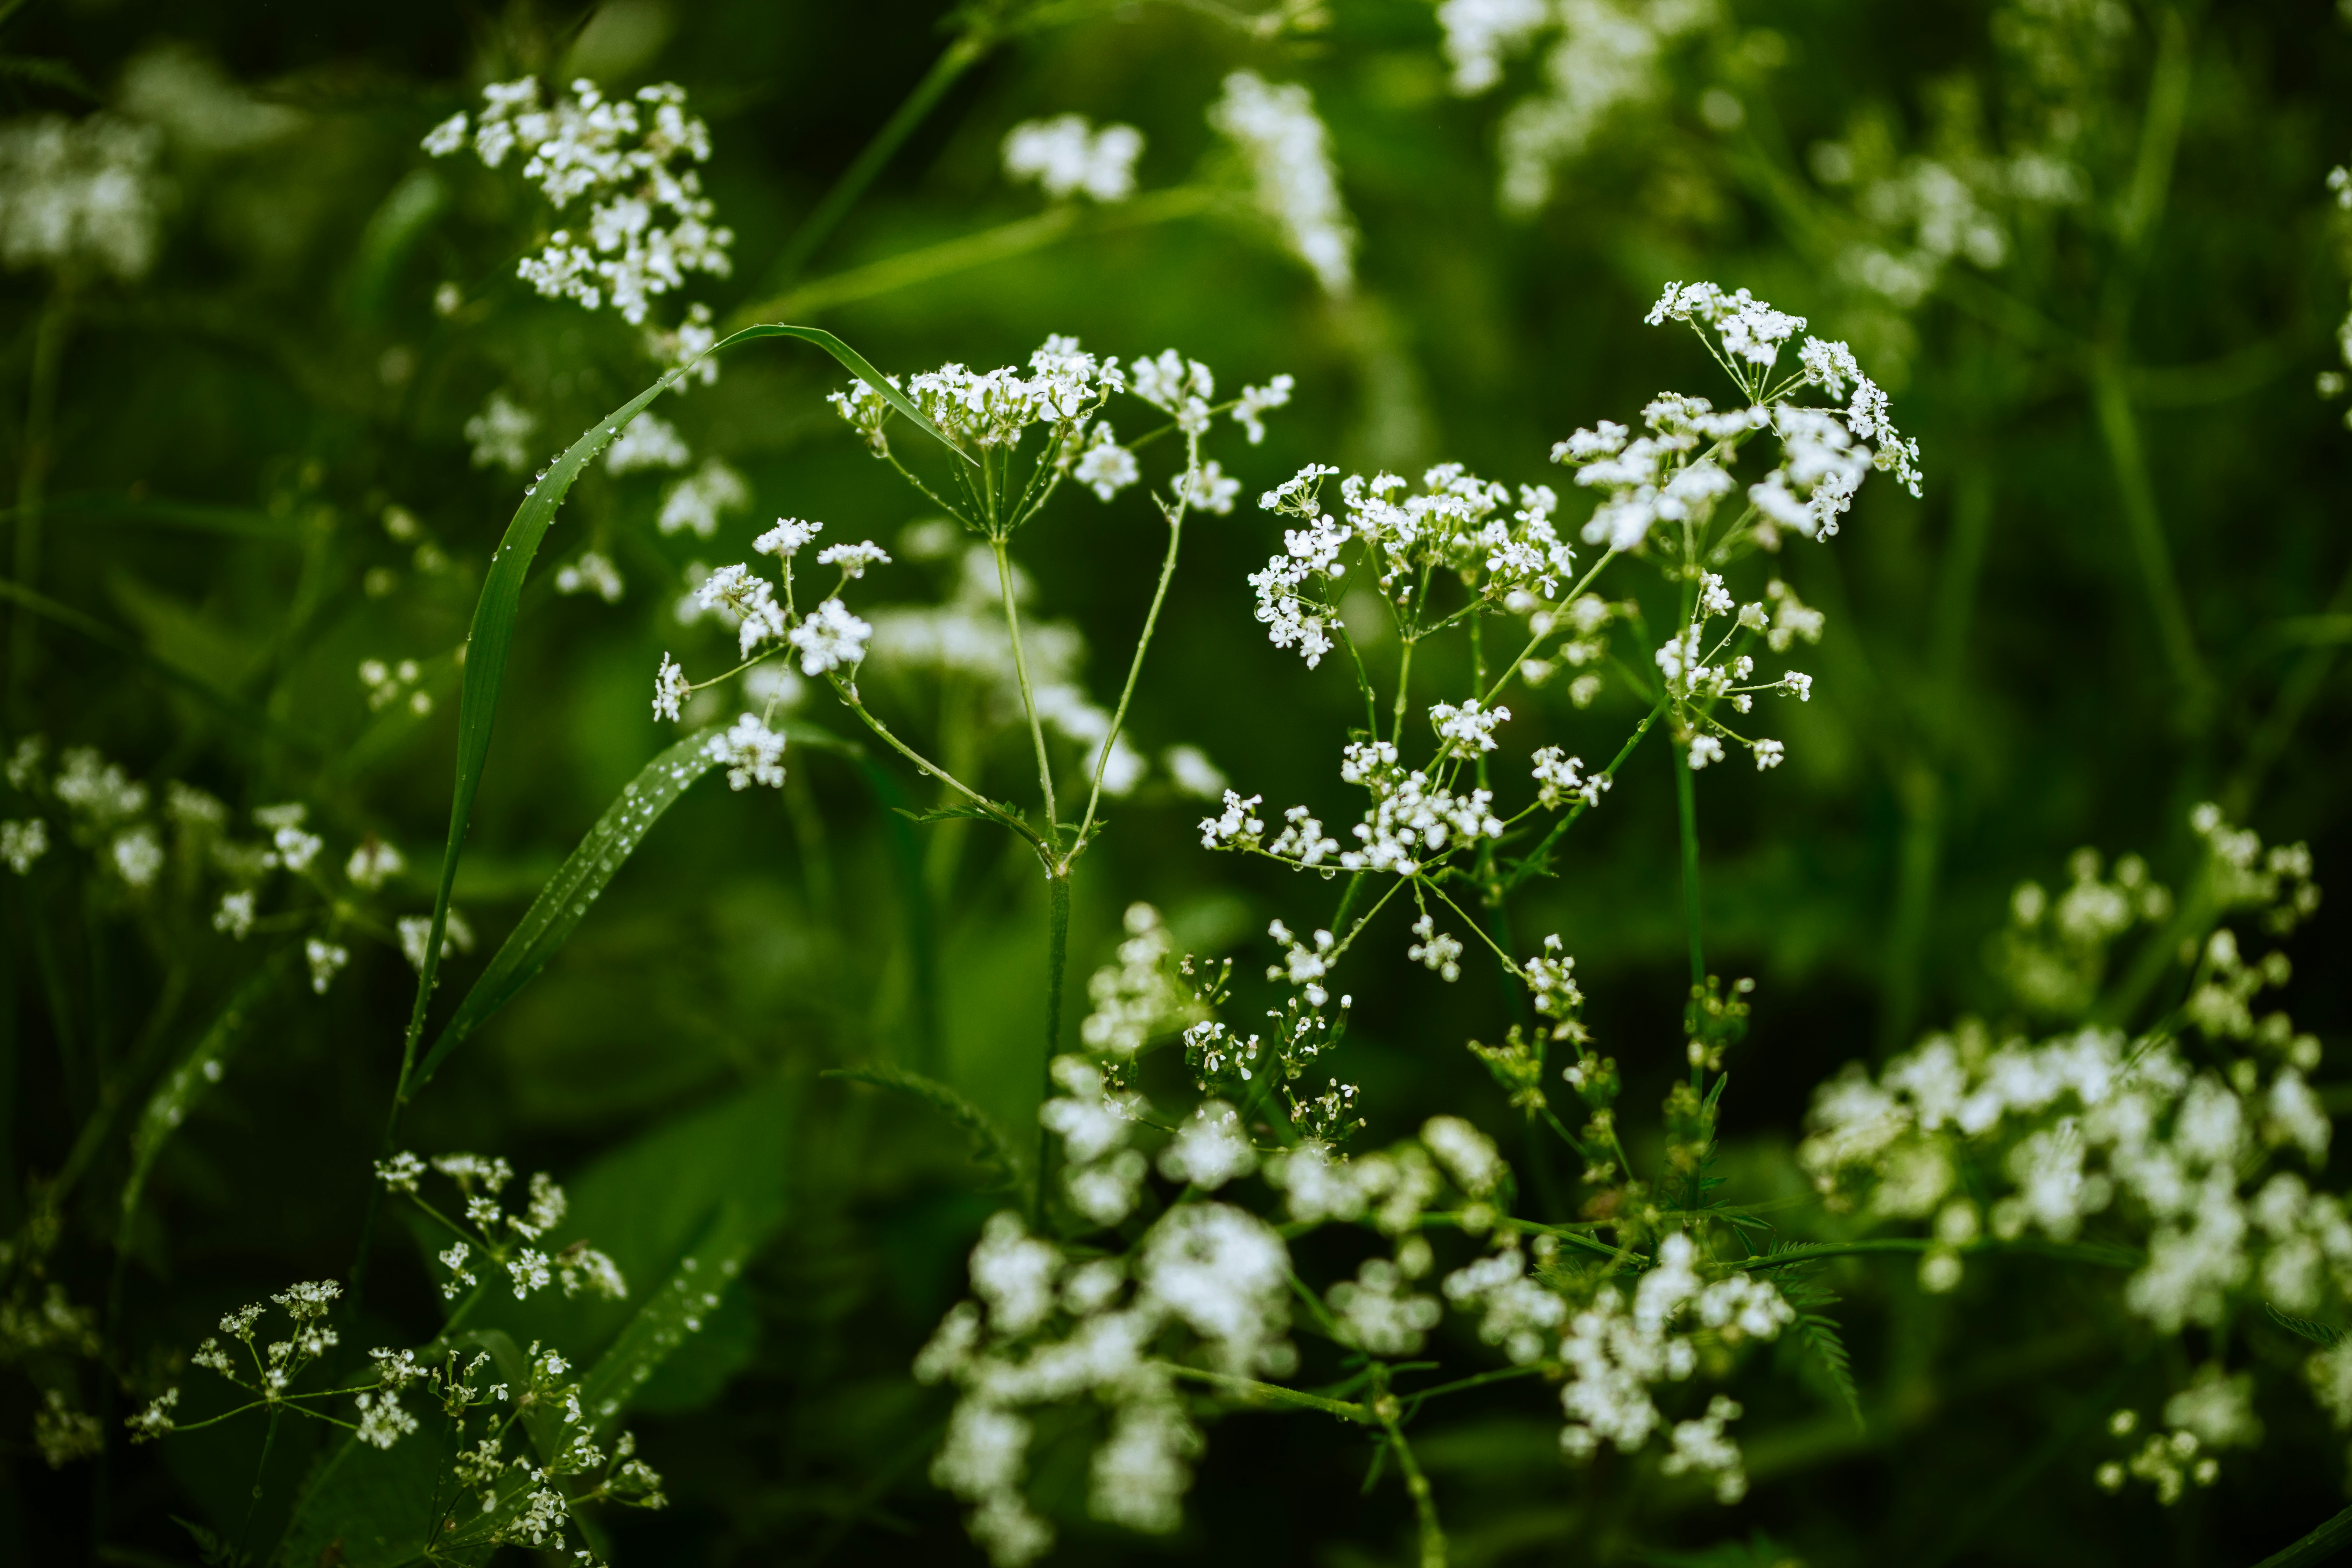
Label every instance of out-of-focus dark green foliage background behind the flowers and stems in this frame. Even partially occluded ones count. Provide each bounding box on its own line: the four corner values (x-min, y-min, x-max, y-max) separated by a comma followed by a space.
0, 0, 2352, 1566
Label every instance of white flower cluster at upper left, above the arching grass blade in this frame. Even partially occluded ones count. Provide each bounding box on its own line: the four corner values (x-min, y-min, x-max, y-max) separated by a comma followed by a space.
424, 78, 734, 327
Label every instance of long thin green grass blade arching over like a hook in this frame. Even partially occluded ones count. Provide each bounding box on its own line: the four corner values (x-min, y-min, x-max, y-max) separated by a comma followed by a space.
400, 324, 971, 1102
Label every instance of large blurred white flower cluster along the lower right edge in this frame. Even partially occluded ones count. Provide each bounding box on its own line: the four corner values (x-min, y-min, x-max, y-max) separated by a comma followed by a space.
1799, 811, 2352, 1500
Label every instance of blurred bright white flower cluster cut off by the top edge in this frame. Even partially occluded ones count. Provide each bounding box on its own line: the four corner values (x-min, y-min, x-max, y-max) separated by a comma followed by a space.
1437, 0, 1738, 214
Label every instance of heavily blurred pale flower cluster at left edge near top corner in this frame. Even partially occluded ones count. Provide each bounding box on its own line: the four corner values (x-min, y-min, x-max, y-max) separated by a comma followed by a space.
0, 115, 162, 282
